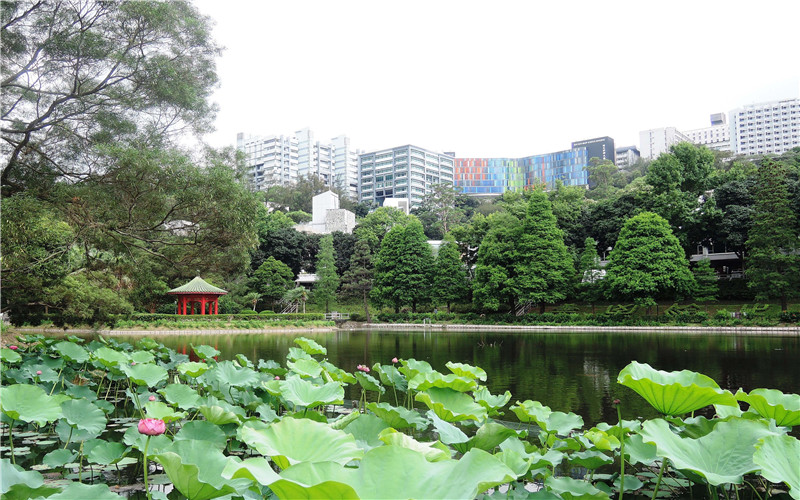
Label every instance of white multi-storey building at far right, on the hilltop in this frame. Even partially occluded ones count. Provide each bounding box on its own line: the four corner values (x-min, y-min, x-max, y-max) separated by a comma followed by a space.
729, 98, 800, 155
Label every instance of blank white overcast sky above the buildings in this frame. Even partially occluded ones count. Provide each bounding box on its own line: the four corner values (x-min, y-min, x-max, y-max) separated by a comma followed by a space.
195, 0, 800, 157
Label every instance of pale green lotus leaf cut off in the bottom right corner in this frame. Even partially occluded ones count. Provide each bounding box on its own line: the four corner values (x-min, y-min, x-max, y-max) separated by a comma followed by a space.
753, 435, 800, 499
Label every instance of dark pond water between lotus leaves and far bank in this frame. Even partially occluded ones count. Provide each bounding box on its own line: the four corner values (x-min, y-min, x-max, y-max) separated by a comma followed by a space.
108, 331, 800, 426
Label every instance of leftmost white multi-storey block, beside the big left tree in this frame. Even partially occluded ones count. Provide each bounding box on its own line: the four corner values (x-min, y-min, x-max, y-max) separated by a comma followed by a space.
236, 132, 298, 190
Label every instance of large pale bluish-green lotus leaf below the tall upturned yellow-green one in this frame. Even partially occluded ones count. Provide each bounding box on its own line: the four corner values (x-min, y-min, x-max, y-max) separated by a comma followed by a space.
640, 419, 775, 486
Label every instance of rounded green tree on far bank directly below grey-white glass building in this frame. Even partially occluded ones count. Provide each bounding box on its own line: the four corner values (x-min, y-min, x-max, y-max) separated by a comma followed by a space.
372, 216, 433, 312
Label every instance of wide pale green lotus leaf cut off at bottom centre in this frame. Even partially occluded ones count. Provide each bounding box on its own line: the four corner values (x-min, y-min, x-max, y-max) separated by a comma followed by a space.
278, 446, 516, 499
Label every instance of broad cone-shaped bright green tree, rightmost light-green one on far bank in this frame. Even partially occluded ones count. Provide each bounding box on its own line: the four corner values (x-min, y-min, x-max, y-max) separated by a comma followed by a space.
605, 212, 694, 309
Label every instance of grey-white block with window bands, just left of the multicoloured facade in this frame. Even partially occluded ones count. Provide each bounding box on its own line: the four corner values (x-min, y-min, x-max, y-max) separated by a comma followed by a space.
358, 145, 455, 207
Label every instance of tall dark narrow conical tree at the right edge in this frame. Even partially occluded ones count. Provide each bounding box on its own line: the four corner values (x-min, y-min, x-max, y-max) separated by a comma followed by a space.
747, 158, 800, 311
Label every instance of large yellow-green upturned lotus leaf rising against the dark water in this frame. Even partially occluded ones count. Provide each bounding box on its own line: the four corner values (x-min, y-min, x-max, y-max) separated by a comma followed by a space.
617, 361, 739, 416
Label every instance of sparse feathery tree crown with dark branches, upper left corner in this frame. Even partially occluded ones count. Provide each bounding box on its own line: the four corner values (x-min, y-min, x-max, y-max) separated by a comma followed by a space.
0, 0, 219, 196
